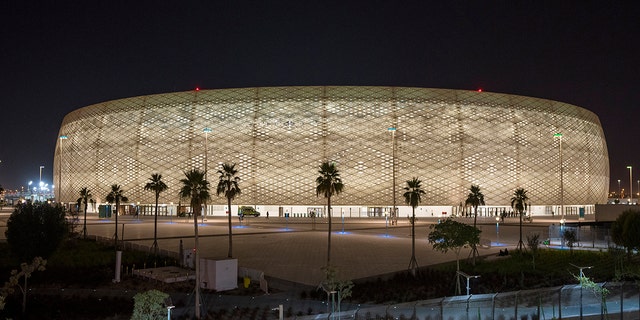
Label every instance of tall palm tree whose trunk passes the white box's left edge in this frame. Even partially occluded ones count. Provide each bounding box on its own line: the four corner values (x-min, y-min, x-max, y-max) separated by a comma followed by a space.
179, 169, 209, 319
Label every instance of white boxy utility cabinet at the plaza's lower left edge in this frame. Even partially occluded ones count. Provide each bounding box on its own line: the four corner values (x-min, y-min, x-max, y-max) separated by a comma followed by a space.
200, 258, 238, 291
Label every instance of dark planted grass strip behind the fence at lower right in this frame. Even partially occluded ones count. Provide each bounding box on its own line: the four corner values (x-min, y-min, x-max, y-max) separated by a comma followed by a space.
352, 249, 640, 303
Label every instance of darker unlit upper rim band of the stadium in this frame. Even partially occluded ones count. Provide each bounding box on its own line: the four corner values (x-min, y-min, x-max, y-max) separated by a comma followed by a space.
63, 86, 602, 126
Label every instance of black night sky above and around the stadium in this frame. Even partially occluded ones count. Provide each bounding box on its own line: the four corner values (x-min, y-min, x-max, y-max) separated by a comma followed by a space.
0, 0, 640, 195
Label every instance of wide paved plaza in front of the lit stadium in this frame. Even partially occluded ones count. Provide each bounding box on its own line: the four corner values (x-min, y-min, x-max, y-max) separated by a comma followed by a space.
0, 208, 571, 286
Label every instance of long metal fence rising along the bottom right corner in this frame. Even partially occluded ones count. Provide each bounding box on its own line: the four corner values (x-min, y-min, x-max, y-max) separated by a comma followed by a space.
291, 282, 640, 320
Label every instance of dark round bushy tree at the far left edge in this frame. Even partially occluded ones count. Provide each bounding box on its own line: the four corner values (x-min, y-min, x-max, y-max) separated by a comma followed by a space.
5, 202, 69, 261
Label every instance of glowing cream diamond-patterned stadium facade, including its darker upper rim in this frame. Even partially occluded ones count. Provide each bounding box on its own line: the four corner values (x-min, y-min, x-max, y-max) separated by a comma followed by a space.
54, 87, 609, 217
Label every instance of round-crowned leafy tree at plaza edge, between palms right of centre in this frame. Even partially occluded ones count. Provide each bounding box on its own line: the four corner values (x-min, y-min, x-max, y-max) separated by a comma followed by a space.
428, 219, 480, 271
